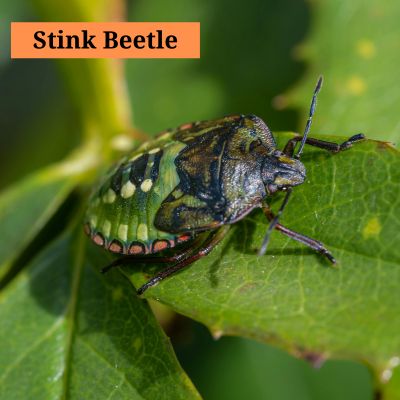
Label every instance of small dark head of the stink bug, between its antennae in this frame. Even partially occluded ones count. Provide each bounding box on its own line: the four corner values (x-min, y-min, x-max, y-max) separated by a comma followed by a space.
262, 150, 306, 194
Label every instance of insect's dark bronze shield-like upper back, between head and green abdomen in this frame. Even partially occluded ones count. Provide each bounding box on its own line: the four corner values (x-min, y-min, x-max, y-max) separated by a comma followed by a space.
155, 116, 275, 232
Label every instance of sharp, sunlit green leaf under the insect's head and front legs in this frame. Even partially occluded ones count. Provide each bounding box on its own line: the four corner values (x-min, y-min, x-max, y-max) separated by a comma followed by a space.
124, 134, 400, 378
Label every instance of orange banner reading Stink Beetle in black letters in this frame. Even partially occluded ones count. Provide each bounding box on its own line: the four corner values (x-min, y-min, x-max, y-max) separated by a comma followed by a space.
11, 22, 200, 58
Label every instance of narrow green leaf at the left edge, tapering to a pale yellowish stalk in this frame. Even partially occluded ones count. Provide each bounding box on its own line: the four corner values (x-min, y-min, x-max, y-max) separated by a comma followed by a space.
0, 143, 98, 280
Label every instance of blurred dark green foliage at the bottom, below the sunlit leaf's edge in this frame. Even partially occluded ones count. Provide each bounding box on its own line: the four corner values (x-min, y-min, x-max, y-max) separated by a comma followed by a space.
176, 323, 372, 400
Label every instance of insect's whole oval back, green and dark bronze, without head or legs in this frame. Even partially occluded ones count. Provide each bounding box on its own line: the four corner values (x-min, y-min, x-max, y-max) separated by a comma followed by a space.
85, 116, 275, 254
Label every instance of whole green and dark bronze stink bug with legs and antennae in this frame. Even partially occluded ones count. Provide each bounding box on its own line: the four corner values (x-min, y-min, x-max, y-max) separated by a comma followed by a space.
85, 77, 364, 295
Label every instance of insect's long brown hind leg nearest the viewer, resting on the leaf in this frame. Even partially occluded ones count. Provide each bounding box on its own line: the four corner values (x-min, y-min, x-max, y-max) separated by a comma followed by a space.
137, 225, 229, 296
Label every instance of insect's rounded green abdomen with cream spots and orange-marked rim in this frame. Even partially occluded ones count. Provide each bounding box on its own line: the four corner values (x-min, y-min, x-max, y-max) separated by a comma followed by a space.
85, 141, 192, 255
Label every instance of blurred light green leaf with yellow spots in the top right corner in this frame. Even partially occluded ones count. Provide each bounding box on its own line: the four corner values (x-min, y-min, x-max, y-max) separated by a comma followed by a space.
290, 0, 400, 143
